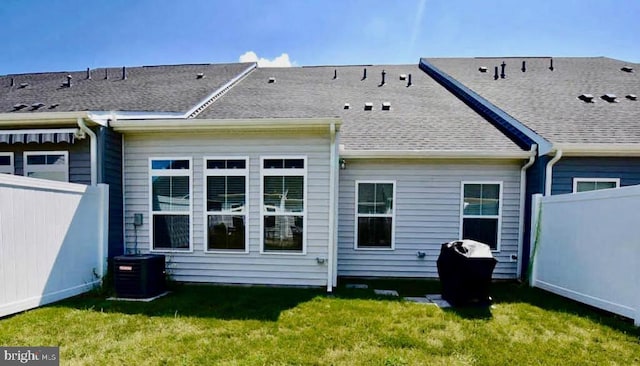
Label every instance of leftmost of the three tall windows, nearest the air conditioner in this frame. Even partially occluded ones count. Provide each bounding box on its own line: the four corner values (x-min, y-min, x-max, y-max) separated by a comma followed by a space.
149, 158, 192, 250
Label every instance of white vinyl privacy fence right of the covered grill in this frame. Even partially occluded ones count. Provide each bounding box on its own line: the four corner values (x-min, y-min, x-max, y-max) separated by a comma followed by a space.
531, 186, 640, 325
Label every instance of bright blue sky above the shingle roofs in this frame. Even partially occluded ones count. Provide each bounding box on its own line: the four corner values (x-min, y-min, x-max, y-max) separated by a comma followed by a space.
0, 0, 640, 75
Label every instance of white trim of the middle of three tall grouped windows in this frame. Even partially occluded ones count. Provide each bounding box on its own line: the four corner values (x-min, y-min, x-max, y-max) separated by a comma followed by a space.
202, 156, 250, 254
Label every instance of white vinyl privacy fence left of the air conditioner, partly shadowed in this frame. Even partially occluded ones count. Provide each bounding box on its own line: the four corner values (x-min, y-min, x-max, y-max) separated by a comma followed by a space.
0, 174, 109, 317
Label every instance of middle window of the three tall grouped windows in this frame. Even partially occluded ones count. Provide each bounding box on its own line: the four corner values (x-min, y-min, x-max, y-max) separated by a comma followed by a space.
204, 158, 248, 252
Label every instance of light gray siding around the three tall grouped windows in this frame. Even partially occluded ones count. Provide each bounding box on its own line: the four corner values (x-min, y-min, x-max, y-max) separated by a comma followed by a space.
124, 132, 330, 286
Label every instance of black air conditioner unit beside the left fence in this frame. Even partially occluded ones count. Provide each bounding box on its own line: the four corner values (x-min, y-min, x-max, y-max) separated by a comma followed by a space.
113, 254, 166, 299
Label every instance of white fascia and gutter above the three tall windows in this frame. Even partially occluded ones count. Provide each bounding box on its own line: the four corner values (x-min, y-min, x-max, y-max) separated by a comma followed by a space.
110, 118, 342, 132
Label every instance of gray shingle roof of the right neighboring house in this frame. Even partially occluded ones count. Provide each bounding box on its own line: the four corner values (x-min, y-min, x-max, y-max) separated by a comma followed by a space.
426, 57, 640, 143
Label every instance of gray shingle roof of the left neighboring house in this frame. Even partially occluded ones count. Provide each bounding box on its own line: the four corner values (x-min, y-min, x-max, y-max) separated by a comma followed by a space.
0, 63, 251, 113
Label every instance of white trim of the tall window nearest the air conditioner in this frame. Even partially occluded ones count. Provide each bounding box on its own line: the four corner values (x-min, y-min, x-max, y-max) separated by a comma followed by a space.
147, 156, 193, 253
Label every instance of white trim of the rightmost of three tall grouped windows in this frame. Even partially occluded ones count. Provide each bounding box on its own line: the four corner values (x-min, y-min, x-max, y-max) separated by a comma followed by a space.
259, 155, 309, 256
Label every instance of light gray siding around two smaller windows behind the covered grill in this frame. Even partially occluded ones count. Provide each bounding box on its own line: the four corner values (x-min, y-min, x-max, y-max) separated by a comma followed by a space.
338, 160, 520, 278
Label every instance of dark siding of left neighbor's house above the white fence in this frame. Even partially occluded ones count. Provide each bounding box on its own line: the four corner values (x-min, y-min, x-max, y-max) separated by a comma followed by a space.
0, 136, 91, 185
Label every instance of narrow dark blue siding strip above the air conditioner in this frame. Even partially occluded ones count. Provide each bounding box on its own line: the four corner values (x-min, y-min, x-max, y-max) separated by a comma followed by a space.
98, 127, 124, 258
